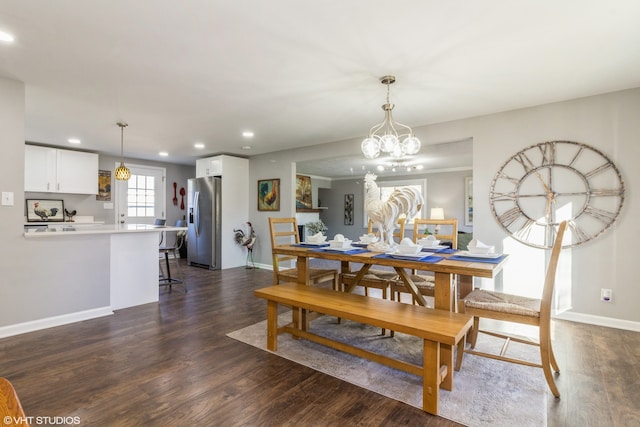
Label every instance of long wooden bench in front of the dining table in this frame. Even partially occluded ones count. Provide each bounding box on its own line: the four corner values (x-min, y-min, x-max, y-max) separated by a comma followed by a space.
254, 283, 473, 415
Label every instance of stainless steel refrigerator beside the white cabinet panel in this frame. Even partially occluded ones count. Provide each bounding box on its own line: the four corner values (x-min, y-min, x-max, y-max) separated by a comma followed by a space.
187, 176, 222, 270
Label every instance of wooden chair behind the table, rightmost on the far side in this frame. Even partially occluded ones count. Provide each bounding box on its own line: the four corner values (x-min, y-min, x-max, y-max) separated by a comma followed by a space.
391, 218, 458, 307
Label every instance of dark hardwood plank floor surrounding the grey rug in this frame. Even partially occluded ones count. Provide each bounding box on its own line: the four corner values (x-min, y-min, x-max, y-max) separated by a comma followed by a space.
0, 264, 640, 426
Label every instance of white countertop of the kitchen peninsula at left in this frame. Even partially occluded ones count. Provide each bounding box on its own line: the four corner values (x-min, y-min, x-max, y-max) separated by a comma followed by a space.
24, 223, 187, 238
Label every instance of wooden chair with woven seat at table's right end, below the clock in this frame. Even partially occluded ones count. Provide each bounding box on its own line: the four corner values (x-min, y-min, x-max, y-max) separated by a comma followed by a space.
456, 221, 567, 397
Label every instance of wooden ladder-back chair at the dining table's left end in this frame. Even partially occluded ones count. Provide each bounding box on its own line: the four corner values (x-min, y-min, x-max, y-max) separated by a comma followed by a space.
269, 217, 339, 290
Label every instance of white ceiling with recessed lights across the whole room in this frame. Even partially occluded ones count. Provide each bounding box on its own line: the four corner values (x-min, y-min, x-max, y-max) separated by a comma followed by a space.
0, 0, 640, 176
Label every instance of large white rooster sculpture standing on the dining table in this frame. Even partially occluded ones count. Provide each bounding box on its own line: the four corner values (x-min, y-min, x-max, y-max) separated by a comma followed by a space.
364, 173, 424, 251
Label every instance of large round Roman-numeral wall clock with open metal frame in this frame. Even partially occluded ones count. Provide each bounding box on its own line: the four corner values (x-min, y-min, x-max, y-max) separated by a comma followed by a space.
489, 141, 624, 248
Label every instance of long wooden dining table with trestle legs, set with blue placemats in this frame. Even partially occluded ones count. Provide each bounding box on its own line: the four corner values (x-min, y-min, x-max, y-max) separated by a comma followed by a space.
273, 245, 508, 311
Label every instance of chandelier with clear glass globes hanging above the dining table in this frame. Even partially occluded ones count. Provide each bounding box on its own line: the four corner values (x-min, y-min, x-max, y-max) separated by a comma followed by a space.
360, 76, 420, 159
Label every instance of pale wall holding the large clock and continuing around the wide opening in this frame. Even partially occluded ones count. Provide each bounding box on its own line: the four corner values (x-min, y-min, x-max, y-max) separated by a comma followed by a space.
250, 89, 640, 330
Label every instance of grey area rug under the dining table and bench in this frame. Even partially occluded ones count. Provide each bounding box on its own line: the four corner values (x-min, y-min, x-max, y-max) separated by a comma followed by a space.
227, 313, 547, 427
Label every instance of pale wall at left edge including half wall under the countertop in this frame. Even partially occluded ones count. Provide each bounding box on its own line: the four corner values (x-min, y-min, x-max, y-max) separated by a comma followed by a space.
0, 78, 109, 333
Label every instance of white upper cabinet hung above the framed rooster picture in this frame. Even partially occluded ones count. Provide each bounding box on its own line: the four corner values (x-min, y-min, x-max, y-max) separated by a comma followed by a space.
24, 145, 98, 194
